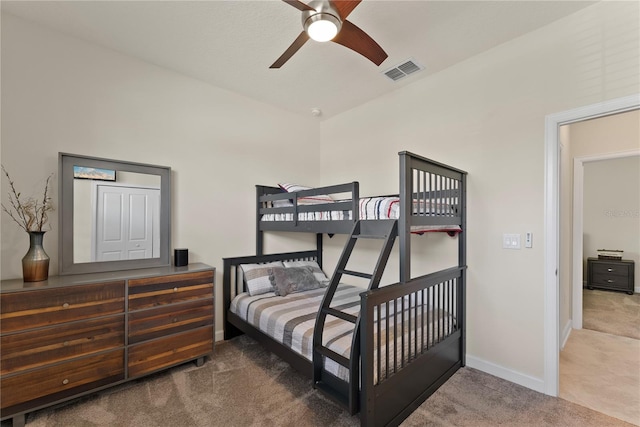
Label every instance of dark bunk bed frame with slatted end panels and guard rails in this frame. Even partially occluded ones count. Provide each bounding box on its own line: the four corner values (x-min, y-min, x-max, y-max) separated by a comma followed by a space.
223, 151, 467, 426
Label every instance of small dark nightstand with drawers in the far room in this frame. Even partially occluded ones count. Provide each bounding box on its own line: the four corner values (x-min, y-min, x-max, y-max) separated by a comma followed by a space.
587, 258, 634, 295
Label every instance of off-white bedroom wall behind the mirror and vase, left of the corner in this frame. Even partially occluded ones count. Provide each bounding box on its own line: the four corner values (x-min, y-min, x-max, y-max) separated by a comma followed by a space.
1, 14, 319, 331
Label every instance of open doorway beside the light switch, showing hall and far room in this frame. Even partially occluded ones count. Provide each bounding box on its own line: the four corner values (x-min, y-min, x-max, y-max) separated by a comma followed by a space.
558, 110, 640, 423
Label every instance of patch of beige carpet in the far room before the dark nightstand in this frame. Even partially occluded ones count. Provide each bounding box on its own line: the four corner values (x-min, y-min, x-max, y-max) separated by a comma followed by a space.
582, 289, 640, 340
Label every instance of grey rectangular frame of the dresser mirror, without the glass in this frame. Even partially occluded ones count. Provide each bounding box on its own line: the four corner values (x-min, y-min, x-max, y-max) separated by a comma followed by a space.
58, 153, 171, 275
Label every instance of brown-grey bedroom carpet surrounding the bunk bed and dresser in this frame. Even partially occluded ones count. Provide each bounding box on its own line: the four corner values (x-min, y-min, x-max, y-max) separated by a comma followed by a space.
2, 337, 629, 427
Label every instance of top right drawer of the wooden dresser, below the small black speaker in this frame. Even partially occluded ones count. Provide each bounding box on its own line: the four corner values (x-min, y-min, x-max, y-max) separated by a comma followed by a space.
129, 271, 213, 311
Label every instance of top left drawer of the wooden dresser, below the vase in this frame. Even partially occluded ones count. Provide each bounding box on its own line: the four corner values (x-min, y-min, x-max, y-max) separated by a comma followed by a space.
0, 281, 125, 334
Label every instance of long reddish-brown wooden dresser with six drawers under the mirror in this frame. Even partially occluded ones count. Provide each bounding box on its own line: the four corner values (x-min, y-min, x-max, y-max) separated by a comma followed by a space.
0, 264, 215, 426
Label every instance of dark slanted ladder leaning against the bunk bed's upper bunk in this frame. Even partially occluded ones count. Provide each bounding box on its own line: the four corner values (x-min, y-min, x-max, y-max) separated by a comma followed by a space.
313, 220, 398, 415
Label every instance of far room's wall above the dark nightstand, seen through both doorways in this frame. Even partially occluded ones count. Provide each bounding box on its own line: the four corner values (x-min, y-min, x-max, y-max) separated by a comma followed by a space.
583, 156, 640, 280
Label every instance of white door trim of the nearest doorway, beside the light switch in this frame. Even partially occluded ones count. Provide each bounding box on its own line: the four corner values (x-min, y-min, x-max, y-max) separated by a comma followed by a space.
544, 94, 640, 396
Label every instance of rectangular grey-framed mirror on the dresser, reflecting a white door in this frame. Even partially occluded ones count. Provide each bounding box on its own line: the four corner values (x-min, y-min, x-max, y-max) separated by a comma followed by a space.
58, 153, 171, 275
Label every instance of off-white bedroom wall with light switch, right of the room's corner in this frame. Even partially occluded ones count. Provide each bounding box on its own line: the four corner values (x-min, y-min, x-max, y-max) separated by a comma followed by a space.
321, 2, 640, 390
